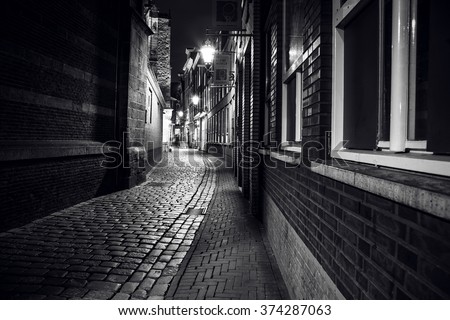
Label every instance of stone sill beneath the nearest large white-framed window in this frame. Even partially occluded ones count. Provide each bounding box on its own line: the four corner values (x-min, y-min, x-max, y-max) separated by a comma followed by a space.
311, 155, 450, 220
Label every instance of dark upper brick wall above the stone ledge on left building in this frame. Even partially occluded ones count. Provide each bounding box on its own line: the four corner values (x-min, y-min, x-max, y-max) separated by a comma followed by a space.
0, 1, 117, 141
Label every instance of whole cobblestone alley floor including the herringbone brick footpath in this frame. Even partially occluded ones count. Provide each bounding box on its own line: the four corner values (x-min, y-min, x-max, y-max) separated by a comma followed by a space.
0, 149, 285, 299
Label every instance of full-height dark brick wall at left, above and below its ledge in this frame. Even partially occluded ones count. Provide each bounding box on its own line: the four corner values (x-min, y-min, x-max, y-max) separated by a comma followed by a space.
0, 0, 118, 230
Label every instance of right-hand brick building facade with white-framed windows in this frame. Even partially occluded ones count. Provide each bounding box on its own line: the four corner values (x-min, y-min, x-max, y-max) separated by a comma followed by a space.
207, 0, 450, 299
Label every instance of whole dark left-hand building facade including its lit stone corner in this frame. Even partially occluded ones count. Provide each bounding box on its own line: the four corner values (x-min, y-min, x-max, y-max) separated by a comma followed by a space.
0, 0, 169, 230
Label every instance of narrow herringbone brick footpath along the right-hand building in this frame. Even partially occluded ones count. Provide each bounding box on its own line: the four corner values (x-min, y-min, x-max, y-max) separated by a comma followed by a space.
167, 159, 287, 300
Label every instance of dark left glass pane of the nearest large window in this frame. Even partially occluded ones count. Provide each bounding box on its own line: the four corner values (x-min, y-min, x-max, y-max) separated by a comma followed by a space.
344, 1, 380, 150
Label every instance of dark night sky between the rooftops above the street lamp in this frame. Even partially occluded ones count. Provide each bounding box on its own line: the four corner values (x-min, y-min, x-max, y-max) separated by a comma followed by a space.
155, 0, 212, 81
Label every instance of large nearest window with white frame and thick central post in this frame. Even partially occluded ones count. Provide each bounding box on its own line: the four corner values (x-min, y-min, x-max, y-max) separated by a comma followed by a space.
332, 0, 450, 175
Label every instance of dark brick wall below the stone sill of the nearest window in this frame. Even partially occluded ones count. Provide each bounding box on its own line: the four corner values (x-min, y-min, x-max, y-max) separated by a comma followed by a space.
263, 161, 450, 299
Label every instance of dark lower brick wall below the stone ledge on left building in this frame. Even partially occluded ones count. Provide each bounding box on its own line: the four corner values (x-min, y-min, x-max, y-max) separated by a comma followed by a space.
0, 156, 116, 231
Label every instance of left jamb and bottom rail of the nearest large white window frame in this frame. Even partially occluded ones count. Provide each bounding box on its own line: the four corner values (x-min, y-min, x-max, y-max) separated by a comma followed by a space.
331, 0, 450, 176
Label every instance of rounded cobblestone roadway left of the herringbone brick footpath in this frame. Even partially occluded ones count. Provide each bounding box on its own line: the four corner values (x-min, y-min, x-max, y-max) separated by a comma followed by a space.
0, 149, 216, 299
